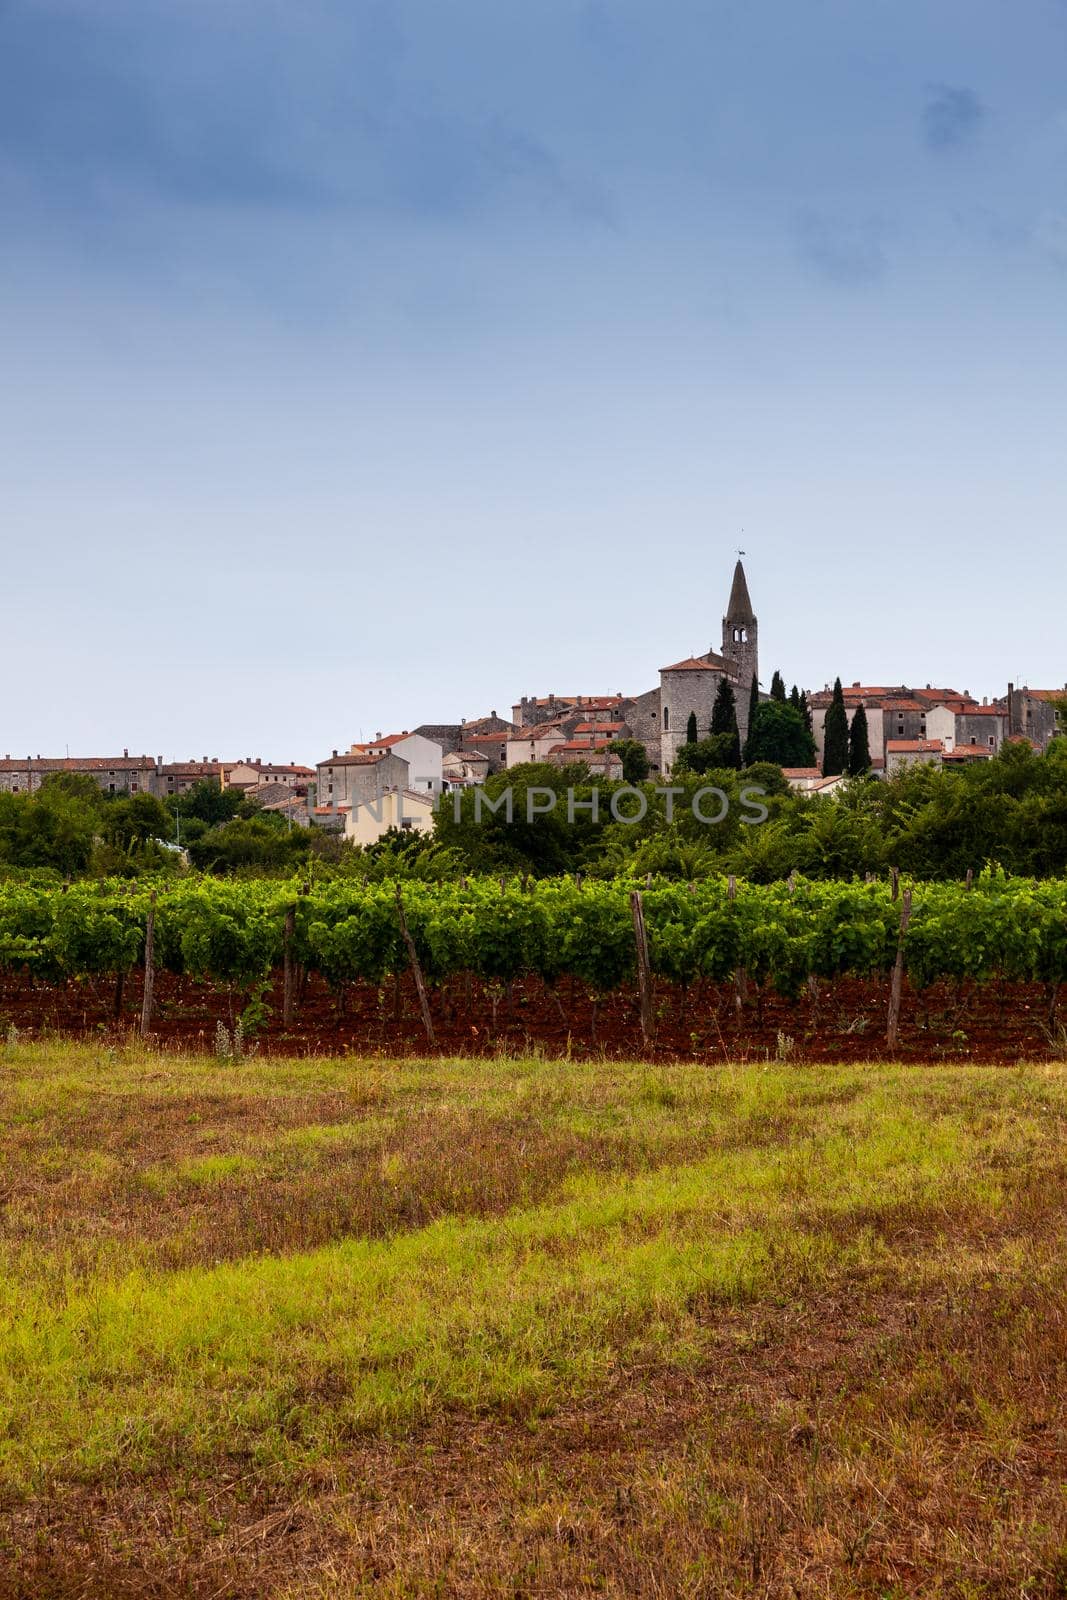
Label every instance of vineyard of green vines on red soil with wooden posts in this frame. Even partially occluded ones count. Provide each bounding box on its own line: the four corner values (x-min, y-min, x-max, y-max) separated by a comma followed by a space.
0, 872, 1067, 1054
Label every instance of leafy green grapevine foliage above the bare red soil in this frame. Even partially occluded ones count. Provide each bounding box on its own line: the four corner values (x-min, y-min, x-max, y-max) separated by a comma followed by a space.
0, 872, 1067, 995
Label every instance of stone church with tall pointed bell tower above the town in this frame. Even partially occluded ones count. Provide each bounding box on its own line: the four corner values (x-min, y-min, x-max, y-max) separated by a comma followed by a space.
625, 562, 760, 774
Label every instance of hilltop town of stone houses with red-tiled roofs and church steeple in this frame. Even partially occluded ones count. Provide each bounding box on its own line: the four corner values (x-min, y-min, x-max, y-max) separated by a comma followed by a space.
0, 560, 1067, 845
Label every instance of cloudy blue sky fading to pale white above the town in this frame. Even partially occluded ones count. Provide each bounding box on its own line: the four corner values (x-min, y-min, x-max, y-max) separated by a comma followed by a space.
0, 0, 1067, 763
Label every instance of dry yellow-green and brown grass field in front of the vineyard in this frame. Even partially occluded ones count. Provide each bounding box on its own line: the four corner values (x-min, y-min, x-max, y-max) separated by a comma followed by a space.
0, 1043, 1067, 1600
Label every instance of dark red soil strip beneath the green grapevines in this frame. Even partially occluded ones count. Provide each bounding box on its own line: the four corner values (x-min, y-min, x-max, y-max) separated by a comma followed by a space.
0, 973, 1064, 1062
